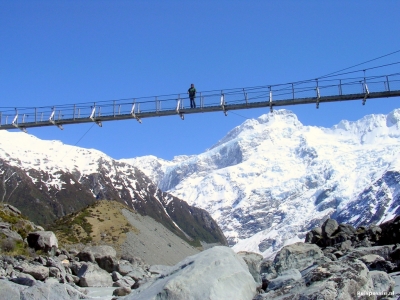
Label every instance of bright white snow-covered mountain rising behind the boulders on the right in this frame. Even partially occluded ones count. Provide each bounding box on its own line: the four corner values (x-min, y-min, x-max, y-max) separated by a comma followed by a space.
122, 109, 400, 257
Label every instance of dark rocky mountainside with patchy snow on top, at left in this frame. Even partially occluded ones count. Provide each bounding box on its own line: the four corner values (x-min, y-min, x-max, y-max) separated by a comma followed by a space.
0, 131, 226, 246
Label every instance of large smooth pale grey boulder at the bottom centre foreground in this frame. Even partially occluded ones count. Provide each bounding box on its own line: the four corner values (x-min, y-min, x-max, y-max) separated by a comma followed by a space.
124, 246, 256, 300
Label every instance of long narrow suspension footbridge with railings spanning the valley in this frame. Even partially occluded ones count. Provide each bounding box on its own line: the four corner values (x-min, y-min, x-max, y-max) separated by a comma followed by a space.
0, 72, 400, 132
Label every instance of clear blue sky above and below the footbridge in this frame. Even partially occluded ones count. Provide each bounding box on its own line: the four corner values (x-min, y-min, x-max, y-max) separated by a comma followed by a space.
0, 0, 400, 159
